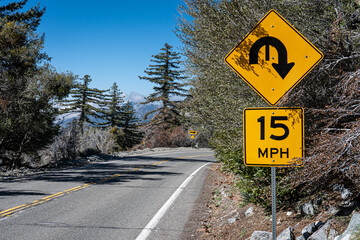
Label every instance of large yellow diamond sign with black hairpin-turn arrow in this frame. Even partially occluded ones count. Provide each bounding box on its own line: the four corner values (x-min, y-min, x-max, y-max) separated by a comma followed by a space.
225, 10, 323, 106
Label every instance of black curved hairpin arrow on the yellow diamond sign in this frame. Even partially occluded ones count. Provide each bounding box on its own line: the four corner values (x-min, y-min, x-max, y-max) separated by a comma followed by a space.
249, 37, 295, 79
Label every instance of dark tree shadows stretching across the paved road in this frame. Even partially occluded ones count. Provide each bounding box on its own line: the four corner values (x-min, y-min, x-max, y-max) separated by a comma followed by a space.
0, 156, 213, 198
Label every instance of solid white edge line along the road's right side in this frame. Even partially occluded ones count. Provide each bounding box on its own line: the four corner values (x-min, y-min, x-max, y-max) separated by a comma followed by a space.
136, 163, 210, 240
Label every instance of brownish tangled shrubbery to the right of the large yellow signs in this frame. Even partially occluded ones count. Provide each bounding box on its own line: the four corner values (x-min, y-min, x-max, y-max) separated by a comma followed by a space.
272, 0, 360, 195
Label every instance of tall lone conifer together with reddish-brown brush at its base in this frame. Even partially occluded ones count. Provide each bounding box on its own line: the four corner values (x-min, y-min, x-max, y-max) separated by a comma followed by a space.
139, 43, 191, 148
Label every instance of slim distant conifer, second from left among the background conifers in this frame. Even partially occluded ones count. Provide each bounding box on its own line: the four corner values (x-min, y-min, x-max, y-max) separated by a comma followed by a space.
100, 83, 124, 127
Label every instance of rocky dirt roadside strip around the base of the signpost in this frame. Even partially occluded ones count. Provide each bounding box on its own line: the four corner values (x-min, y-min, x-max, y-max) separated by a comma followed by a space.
182, 163, 360, 240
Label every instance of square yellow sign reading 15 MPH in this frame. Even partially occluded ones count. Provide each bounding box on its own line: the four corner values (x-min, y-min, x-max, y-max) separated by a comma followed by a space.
243, 108, 305, 167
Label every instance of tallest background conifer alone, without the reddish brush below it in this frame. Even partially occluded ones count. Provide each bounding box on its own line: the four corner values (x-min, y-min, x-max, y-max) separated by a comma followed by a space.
139, 43, 187, 129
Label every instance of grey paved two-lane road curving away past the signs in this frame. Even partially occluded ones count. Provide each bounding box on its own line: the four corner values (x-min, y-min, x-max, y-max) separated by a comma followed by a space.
0, 149, 215, 240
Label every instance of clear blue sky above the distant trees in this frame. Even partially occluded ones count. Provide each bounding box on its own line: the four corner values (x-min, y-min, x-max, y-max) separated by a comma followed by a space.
22, 0, 182, 101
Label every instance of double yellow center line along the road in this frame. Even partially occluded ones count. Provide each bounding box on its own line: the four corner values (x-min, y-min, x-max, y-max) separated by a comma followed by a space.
0, 154, 212, 218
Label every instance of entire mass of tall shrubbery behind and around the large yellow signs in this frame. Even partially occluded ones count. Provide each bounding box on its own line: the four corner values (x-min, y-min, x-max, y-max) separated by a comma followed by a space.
177, 0, 360, 207
